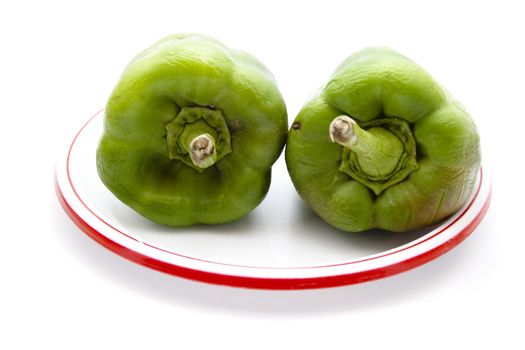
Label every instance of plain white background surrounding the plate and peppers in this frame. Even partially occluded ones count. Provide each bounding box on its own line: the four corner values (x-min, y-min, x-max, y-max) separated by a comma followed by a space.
0, 0, 525, 349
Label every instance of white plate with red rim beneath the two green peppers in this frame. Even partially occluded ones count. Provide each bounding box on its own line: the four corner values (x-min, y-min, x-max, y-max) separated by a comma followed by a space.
56, 111, 491, 289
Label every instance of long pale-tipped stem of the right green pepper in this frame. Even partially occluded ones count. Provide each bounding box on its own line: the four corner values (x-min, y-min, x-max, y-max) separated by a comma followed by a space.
329, 115, 404, 177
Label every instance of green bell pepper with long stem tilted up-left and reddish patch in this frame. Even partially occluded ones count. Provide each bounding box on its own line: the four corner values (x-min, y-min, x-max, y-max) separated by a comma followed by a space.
286, 48, 480, 232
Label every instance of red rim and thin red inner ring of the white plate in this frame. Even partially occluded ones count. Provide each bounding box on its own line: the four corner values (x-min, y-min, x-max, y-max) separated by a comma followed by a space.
55, 110, 492, 290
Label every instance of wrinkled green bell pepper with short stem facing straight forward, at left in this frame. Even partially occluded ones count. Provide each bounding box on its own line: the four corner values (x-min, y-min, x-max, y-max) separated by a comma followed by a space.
97, 34, 287, 226
